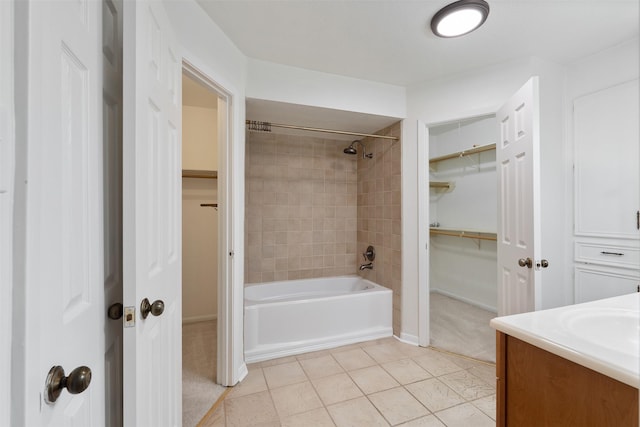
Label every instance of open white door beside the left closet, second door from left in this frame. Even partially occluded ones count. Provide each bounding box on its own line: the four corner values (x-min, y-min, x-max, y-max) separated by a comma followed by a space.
123, 0, 182, 427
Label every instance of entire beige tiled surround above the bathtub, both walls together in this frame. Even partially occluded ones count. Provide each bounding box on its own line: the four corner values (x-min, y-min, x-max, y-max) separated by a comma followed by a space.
244, 122, 402, 335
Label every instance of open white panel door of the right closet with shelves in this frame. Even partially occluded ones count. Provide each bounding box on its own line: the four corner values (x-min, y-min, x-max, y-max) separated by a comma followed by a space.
496, 77, 542, 316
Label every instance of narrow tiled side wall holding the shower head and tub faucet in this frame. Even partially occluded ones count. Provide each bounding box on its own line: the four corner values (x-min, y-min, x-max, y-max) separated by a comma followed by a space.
358, 122, 402, 336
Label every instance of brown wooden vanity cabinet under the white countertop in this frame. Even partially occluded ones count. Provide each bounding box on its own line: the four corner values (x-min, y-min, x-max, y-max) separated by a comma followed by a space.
496, 331, 639, 427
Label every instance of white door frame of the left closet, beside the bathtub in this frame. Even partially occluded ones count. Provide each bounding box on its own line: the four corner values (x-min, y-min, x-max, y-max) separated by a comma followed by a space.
182, 57, 242, 386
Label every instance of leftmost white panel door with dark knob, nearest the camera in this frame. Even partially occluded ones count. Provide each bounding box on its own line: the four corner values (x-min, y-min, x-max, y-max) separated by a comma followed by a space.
25, 0, 105, 426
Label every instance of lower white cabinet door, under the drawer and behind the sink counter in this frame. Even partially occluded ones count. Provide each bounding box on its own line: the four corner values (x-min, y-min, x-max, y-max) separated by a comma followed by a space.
575, 264, 640, 303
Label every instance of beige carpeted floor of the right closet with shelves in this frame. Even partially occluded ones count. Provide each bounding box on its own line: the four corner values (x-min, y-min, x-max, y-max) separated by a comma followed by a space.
429, 292, 497, 363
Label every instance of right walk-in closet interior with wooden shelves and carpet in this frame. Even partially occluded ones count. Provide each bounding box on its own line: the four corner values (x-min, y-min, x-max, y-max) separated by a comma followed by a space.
429, 115, 498, 361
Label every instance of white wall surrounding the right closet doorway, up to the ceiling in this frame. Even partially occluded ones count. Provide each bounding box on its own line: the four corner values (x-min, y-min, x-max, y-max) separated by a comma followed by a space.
402, 58, 572, 342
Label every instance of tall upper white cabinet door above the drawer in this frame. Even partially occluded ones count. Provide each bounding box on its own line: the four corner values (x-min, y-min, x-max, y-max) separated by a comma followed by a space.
573, 80, 640, 239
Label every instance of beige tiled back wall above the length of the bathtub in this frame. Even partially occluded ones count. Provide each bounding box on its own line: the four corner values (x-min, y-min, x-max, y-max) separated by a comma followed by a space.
245, 132, 358, 283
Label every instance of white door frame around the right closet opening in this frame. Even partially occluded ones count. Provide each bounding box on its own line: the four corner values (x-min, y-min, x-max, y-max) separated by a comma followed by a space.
418, 106, 500, 347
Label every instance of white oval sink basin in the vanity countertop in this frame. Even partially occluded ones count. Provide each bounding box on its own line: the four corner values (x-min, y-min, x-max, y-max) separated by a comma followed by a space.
559, 307, 640, 357
